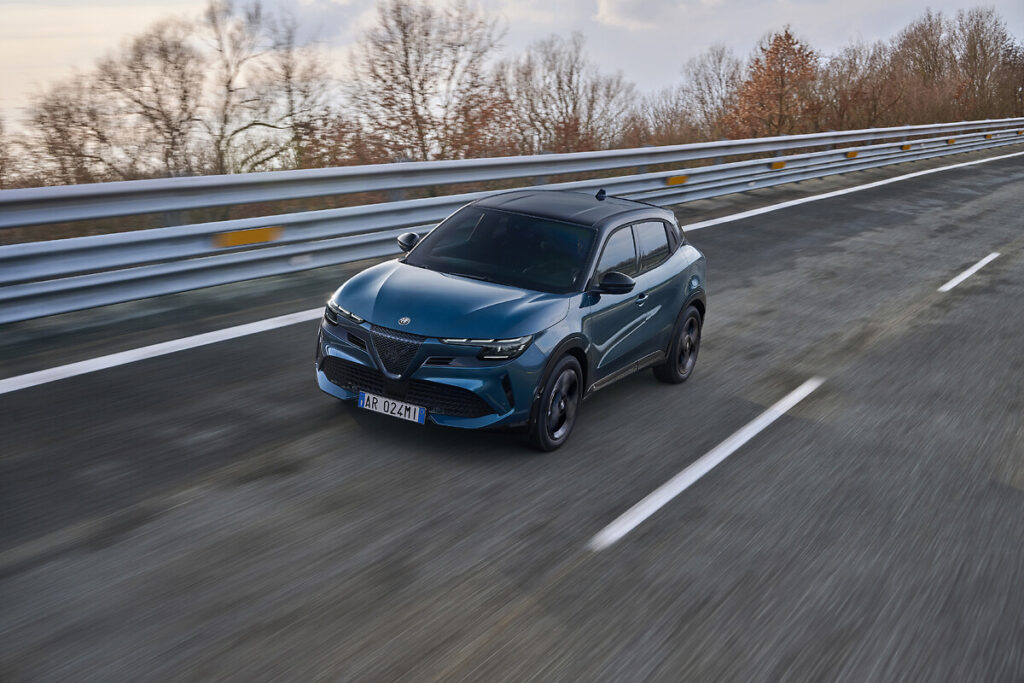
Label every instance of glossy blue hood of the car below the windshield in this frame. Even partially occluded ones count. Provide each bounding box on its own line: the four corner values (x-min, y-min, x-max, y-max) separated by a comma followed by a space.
335, 260, 569, 339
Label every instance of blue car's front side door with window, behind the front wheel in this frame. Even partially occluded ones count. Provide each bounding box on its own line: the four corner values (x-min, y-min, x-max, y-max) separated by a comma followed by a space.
583, 225, 646, 383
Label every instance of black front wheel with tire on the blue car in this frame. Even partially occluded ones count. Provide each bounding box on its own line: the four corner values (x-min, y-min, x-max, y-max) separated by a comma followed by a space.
528, 355, 583, 452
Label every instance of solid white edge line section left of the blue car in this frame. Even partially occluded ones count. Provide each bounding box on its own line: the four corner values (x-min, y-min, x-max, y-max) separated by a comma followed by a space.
0, 308, 324, 394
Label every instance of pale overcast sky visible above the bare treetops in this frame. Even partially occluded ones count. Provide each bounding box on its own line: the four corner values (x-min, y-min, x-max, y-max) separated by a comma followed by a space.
6, 0, 1024, 125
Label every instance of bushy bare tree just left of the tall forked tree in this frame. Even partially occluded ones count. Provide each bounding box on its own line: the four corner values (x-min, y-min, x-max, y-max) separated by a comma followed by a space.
96, 20, 204, 175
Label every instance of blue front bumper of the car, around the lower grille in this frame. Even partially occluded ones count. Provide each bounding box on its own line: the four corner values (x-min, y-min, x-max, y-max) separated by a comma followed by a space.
316, 319, 547, 429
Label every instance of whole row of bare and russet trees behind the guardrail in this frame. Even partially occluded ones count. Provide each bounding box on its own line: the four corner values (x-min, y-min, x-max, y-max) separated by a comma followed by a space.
0, 0, 1024, 188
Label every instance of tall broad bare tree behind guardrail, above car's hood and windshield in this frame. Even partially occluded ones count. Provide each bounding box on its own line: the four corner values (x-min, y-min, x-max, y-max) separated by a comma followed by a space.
348, 0, 503, 160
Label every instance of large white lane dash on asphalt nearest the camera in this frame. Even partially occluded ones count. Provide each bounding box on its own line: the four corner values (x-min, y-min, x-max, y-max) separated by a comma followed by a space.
588, 377, 825, 551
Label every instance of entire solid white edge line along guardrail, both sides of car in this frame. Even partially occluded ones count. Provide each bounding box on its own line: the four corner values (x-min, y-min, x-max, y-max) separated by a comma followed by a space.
0, 152, 1024, 394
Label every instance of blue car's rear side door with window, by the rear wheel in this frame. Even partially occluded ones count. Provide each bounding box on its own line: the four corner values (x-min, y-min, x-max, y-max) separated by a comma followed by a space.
633, 220, 683, 360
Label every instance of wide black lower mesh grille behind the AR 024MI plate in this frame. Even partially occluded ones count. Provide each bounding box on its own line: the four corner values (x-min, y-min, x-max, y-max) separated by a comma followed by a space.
322, 355, 495, 418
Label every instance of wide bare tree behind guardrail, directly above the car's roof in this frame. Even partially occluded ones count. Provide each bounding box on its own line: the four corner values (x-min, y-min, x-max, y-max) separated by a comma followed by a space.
502, 33, 635, 154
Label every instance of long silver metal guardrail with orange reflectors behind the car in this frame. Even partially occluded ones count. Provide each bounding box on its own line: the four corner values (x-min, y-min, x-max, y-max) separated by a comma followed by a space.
0, 118, 1024, 324
